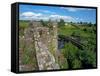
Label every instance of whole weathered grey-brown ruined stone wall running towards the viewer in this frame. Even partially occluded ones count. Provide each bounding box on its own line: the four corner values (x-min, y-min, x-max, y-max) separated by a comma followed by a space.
21, 21, 59, 70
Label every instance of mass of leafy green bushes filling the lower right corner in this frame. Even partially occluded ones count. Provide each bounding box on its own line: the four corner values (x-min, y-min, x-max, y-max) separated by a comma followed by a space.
61, 39, 96, 69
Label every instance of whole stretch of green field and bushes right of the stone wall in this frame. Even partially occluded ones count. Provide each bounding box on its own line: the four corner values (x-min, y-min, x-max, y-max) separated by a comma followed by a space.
58, 23, 96, 69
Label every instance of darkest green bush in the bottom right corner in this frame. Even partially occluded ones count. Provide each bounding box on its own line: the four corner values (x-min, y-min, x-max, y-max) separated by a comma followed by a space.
79, 50, 96, 68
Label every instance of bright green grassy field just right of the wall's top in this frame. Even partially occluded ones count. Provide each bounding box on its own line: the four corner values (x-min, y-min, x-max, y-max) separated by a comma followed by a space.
58, 25, 91, 37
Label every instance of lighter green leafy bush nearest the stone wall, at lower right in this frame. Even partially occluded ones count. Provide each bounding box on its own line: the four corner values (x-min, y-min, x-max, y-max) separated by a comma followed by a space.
62, 43, 81, 69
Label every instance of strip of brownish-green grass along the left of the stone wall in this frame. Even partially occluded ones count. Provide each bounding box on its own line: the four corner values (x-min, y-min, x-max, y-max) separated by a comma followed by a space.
19, 21, 38, 70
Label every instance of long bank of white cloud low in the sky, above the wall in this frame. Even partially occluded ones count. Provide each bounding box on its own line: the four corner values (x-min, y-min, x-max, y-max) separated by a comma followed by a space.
20, 11, 74, 21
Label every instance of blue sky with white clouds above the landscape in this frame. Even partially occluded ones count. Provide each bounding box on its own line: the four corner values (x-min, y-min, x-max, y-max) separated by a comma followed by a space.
19, 4, 96, 23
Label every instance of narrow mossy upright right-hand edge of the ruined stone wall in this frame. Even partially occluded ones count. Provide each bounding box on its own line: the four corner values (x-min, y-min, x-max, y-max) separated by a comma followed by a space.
49, 22, 58, 62
